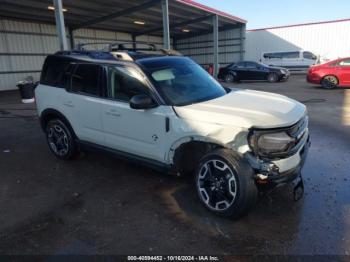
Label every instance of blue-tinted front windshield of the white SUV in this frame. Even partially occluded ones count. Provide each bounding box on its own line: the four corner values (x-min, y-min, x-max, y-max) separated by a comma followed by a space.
142, 57, 226, 106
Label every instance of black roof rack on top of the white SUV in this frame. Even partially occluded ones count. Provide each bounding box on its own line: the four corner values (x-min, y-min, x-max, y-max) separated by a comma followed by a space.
62, 41, 182, 61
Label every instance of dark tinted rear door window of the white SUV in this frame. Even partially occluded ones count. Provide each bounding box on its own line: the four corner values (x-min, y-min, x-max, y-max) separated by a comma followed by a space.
70, 64, 102, 96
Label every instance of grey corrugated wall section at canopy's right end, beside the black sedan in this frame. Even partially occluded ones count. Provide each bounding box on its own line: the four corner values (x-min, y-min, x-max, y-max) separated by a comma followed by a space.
175, 26, 245, 66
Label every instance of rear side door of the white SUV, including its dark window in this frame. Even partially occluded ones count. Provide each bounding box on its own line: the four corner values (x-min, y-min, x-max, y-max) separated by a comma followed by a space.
61, 64, 104, 145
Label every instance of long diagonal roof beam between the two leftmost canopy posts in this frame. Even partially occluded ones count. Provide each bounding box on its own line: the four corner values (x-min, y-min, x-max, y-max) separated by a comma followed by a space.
72, 0, 160, 30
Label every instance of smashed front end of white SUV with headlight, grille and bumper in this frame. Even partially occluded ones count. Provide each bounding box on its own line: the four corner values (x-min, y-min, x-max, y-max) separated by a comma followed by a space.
244, 116, 311, 194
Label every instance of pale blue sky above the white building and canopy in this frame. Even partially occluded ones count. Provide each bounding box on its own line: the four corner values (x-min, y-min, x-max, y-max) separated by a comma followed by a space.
195, 0, 350, 29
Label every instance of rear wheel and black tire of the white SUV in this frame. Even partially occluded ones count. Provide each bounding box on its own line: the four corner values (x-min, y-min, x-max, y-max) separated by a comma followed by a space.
45, 118, 78, 160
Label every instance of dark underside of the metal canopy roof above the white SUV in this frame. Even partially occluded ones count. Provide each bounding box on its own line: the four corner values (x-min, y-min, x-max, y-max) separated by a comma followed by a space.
0, 0, 246, 38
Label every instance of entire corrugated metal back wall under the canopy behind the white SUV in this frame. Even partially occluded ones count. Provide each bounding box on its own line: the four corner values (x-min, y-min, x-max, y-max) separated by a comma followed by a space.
0, 19, 245, 91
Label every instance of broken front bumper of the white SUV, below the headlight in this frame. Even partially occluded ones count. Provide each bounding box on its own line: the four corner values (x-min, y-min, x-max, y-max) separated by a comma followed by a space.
245, 135, 311, 186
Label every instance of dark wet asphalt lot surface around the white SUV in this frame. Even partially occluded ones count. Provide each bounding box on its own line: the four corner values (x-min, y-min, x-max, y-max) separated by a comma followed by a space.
0, 75, 350, 255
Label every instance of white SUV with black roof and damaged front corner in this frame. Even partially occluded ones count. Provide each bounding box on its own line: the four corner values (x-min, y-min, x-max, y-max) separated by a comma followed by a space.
35, 46, 309, 217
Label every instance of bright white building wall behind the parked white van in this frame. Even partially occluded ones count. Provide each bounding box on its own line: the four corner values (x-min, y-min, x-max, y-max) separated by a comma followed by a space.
245, 20, 350, 61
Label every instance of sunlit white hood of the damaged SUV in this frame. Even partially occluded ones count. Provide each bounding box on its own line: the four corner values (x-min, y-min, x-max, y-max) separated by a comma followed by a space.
174, 90, 306, 128
